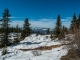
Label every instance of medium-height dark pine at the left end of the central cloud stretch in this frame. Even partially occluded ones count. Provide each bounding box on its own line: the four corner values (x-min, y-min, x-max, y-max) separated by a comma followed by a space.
22, 18, 31, 38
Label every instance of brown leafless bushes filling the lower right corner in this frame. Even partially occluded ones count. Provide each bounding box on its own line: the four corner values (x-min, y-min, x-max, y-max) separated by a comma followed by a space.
61, 29, 80, 60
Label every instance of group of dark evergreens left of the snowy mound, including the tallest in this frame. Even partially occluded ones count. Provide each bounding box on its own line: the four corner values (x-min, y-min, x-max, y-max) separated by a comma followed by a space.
0, 8, 31, 47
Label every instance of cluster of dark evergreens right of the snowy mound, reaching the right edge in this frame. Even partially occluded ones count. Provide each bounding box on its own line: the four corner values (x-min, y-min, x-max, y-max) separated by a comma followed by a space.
51, 13, 80, 39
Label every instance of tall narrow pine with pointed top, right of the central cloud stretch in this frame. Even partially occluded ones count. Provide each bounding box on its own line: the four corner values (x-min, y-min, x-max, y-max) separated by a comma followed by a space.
53, 15, 62, 38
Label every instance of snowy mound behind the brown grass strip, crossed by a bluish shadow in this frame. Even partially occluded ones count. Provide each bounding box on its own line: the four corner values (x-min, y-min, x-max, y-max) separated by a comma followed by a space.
11, 34, 61, 49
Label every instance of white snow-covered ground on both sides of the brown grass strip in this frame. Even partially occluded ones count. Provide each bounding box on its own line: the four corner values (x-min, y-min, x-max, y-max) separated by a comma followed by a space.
0, 34, 67, 60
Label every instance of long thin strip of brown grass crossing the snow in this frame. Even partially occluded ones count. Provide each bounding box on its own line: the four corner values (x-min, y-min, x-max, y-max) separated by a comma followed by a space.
19, 44, 62, 51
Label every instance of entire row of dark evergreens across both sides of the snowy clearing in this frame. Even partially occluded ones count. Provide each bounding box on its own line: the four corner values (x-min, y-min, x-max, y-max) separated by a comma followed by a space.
0, 9, 80, 45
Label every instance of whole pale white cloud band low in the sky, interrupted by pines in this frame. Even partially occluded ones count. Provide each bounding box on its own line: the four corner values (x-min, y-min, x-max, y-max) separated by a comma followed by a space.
10, 18, 71, 28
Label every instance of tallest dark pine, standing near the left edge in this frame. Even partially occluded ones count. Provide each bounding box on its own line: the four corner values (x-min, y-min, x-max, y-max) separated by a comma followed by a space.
1, 9, 10, 45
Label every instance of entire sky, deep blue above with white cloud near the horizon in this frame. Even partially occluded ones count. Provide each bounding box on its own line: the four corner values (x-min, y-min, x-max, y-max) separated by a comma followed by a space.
0, 0, 80, 28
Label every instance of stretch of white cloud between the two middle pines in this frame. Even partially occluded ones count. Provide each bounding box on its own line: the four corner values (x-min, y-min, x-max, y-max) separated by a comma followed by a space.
30, 19, 56, 28
